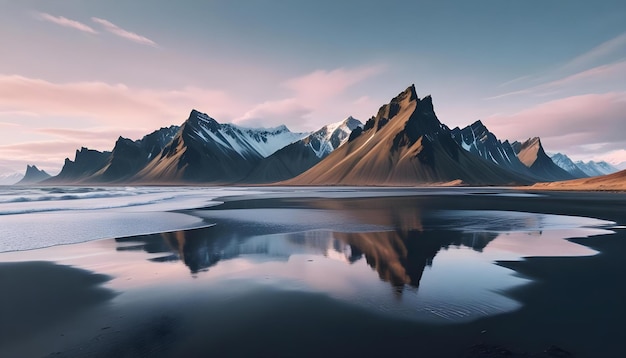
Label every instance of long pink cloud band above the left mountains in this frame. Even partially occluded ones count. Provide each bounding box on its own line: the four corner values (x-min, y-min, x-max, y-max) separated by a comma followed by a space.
0, 75, 236, 127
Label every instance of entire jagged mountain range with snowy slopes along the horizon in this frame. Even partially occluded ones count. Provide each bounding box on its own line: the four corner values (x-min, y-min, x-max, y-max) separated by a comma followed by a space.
6, 85, 617, 189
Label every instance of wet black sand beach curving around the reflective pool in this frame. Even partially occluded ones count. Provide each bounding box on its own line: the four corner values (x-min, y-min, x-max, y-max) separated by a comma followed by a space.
0, 190, 626, 357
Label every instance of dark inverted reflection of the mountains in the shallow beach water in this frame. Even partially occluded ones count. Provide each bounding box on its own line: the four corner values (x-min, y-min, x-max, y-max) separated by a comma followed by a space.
117, 198, 497, 292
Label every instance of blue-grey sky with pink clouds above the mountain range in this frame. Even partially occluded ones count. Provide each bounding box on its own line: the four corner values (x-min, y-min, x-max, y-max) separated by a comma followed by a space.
0, 0, 626, 174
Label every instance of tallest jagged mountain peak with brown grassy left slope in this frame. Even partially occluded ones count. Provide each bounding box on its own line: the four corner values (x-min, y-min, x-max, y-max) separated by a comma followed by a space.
288, 85, 524, 185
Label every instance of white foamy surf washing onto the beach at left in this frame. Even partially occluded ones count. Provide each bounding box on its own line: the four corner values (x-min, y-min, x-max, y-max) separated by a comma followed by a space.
0, 187, 260, 252
